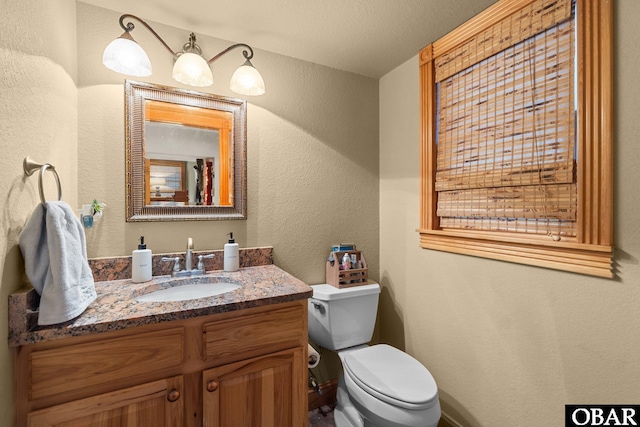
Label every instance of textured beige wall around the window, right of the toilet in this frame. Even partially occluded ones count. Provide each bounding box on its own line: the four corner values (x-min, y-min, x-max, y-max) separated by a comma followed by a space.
380, 1, 640, 427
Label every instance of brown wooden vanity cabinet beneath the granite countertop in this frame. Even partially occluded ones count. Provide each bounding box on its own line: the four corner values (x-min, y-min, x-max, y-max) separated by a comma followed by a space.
14, 300, 307, 427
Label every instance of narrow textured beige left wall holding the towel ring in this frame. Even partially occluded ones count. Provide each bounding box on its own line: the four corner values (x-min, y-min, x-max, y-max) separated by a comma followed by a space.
0, 0, 77, 425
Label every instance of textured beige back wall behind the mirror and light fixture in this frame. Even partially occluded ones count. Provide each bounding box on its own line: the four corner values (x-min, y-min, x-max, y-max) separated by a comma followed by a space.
77, 4, 378, 283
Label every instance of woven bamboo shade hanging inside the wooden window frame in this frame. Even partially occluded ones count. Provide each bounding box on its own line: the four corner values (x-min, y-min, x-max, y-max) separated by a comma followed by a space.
435, 0, 576, 236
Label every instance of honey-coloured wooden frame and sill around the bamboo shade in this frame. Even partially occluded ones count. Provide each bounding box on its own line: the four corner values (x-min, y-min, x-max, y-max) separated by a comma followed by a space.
418, 0, 613, 278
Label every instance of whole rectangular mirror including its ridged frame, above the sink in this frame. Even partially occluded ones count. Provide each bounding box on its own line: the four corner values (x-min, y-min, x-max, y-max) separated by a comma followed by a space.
125, 81, 247, 221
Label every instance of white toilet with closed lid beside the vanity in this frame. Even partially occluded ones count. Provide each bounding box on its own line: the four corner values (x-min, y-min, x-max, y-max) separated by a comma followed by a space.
309, 283, 440, 427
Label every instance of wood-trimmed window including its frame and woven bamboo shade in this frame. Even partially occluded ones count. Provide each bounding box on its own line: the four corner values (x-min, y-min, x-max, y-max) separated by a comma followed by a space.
419, 0, 613, 277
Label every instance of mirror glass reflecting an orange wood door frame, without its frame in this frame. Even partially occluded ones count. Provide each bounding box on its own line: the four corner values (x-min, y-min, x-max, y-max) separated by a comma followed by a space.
145, 101, 233, 206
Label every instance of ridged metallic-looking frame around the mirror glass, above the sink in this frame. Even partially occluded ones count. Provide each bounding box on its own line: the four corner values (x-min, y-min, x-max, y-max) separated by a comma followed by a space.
125, 80, 247, 222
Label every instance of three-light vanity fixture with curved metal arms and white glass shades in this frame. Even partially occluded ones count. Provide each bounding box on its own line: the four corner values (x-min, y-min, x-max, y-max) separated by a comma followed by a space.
102, 14, 265, 95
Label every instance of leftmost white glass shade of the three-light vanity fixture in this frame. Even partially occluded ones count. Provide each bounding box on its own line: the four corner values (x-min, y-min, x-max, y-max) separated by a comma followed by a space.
102, 33, 151, 77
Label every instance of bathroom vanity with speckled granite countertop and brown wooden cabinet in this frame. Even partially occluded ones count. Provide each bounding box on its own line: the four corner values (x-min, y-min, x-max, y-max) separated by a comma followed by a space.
9, 265, 312, 427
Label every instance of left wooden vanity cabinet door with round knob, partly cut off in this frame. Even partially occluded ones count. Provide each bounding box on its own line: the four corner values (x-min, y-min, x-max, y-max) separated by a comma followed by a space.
27, 376, 184, 427
